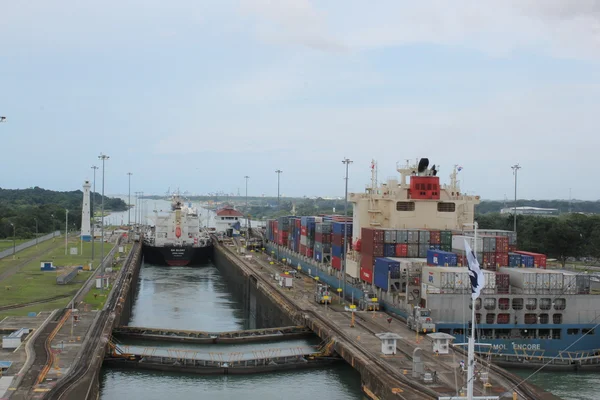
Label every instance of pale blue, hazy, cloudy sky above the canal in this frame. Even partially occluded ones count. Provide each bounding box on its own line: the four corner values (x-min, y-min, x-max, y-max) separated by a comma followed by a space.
0, 0, 600, 200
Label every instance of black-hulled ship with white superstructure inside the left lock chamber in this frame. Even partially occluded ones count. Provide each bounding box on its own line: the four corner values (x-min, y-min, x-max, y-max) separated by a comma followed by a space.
142, 194, 213, 266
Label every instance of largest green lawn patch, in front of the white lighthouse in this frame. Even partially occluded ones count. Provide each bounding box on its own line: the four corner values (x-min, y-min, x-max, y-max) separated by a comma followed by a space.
0, 238, 112, 309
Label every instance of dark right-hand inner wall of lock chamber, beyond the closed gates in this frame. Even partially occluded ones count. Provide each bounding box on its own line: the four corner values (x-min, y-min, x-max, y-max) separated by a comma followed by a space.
213, 247, 294, 329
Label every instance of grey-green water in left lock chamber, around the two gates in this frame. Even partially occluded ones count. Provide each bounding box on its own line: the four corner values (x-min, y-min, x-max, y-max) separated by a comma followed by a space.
100, 264, 366, 400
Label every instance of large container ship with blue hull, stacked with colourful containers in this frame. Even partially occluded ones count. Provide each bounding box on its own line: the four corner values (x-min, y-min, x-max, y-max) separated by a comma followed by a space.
266, 159, 600, 364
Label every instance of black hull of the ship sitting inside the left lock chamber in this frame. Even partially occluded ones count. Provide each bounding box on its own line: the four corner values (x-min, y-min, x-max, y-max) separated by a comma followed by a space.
142, 244, 213, 267
